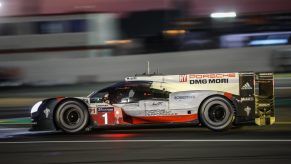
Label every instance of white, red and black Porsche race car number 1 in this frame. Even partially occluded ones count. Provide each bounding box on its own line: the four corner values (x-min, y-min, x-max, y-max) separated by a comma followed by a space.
31, 72, 275, 133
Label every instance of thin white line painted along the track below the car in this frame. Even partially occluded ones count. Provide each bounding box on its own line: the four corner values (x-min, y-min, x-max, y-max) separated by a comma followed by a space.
0, 139, 291, 144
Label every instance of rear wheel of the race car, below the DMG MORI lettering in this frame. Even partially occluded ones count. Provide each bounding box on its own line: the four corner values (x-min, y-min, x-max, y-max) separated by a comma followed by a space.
199, 96, 234, 131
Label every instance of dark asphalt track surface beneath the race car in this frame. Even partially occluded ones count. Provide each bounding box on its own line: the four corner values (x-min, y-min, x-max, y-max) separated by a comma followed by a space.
0, 107, 291, 164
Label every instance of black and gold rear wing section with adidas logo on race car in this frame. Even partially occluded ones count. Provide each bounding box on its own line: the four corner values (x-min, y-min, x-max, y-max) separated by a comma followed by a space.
237, 72, 275, 126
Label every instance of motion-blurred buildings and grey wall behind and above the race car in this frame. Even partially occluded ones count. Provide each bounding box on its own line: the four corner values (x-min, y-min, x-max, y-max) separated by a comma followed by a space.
0, 0, 291, 105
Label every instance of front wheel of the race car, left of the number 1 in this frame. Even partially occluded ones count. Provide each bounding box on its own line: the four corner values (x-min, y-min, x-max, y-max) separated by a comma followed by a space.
55, 101, 89, 133
